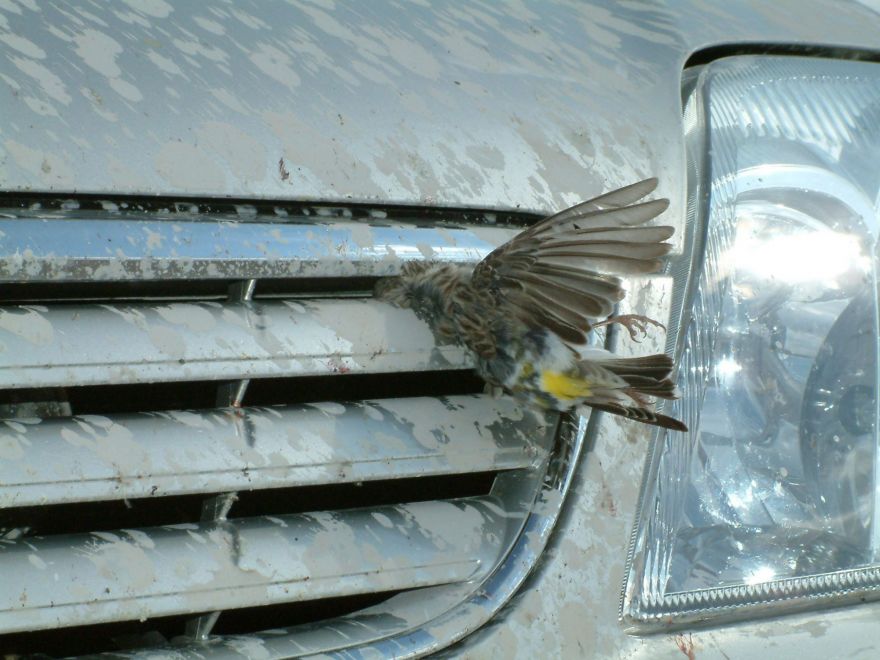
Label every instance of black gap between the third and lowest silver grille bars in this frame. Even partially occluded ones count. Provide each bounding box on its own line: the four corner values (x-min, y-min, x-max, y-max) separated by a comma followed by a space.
0, 472, 497, 538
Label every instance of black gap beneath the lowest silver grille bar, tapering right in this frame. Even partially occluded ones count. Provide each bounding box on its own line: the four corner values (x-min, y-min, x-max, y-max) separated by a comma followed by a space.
0, 591, 400, 658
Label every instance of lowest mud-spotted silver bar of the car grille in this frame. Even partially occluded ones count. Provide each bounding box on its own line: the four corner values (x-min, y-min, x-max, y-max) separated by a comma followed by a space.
0, 497, 508, 633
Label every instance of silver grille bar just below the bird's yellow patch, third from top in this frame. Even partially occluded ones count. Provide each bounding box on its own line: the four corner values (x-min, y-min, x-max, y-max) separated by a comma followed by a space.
0, 395, 555, 508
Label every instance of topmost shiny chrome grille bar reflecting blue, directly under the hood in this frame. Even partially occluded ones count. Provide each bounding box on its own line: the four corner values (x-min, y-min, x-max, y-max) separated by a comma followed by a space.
0, 217, 516, 282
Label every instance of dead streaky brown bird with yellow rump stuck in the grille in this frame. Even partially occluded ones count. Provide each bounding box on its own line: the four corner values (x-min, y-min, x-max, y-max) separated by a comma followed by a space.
374, 178, 687, 432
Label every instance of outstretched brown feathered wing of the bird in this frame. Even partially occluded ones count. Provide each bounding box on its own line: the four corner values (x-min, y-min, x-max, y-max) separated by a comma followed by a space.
472, 179, 675, 344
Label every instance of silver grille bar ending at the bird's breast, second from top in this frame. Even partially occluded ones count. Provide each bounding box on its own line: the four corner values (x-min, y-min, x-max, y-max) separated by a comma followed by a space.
0, 299, 469, 388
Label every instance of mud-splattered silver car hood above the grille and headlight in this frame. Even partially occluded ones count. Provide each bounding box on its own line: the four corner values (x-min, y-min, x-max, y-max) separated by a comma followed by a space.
0, 0, 876, 212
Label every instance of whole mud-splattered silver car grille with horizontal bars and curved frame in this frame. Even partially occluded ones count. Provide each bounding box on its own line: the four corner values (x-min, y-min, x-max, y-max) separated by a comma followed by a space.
0, 197, 584, 657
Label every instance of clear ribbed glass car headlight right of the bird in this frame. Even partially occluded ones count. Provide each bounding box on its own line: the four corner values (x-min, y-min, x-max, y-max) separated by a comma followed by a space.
622, 56, 880, 630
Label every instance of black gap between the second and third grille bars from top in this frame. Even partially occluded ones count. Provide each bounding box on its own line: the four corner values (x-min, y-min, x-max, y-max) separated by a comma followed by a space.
0, 369, 483, 415
